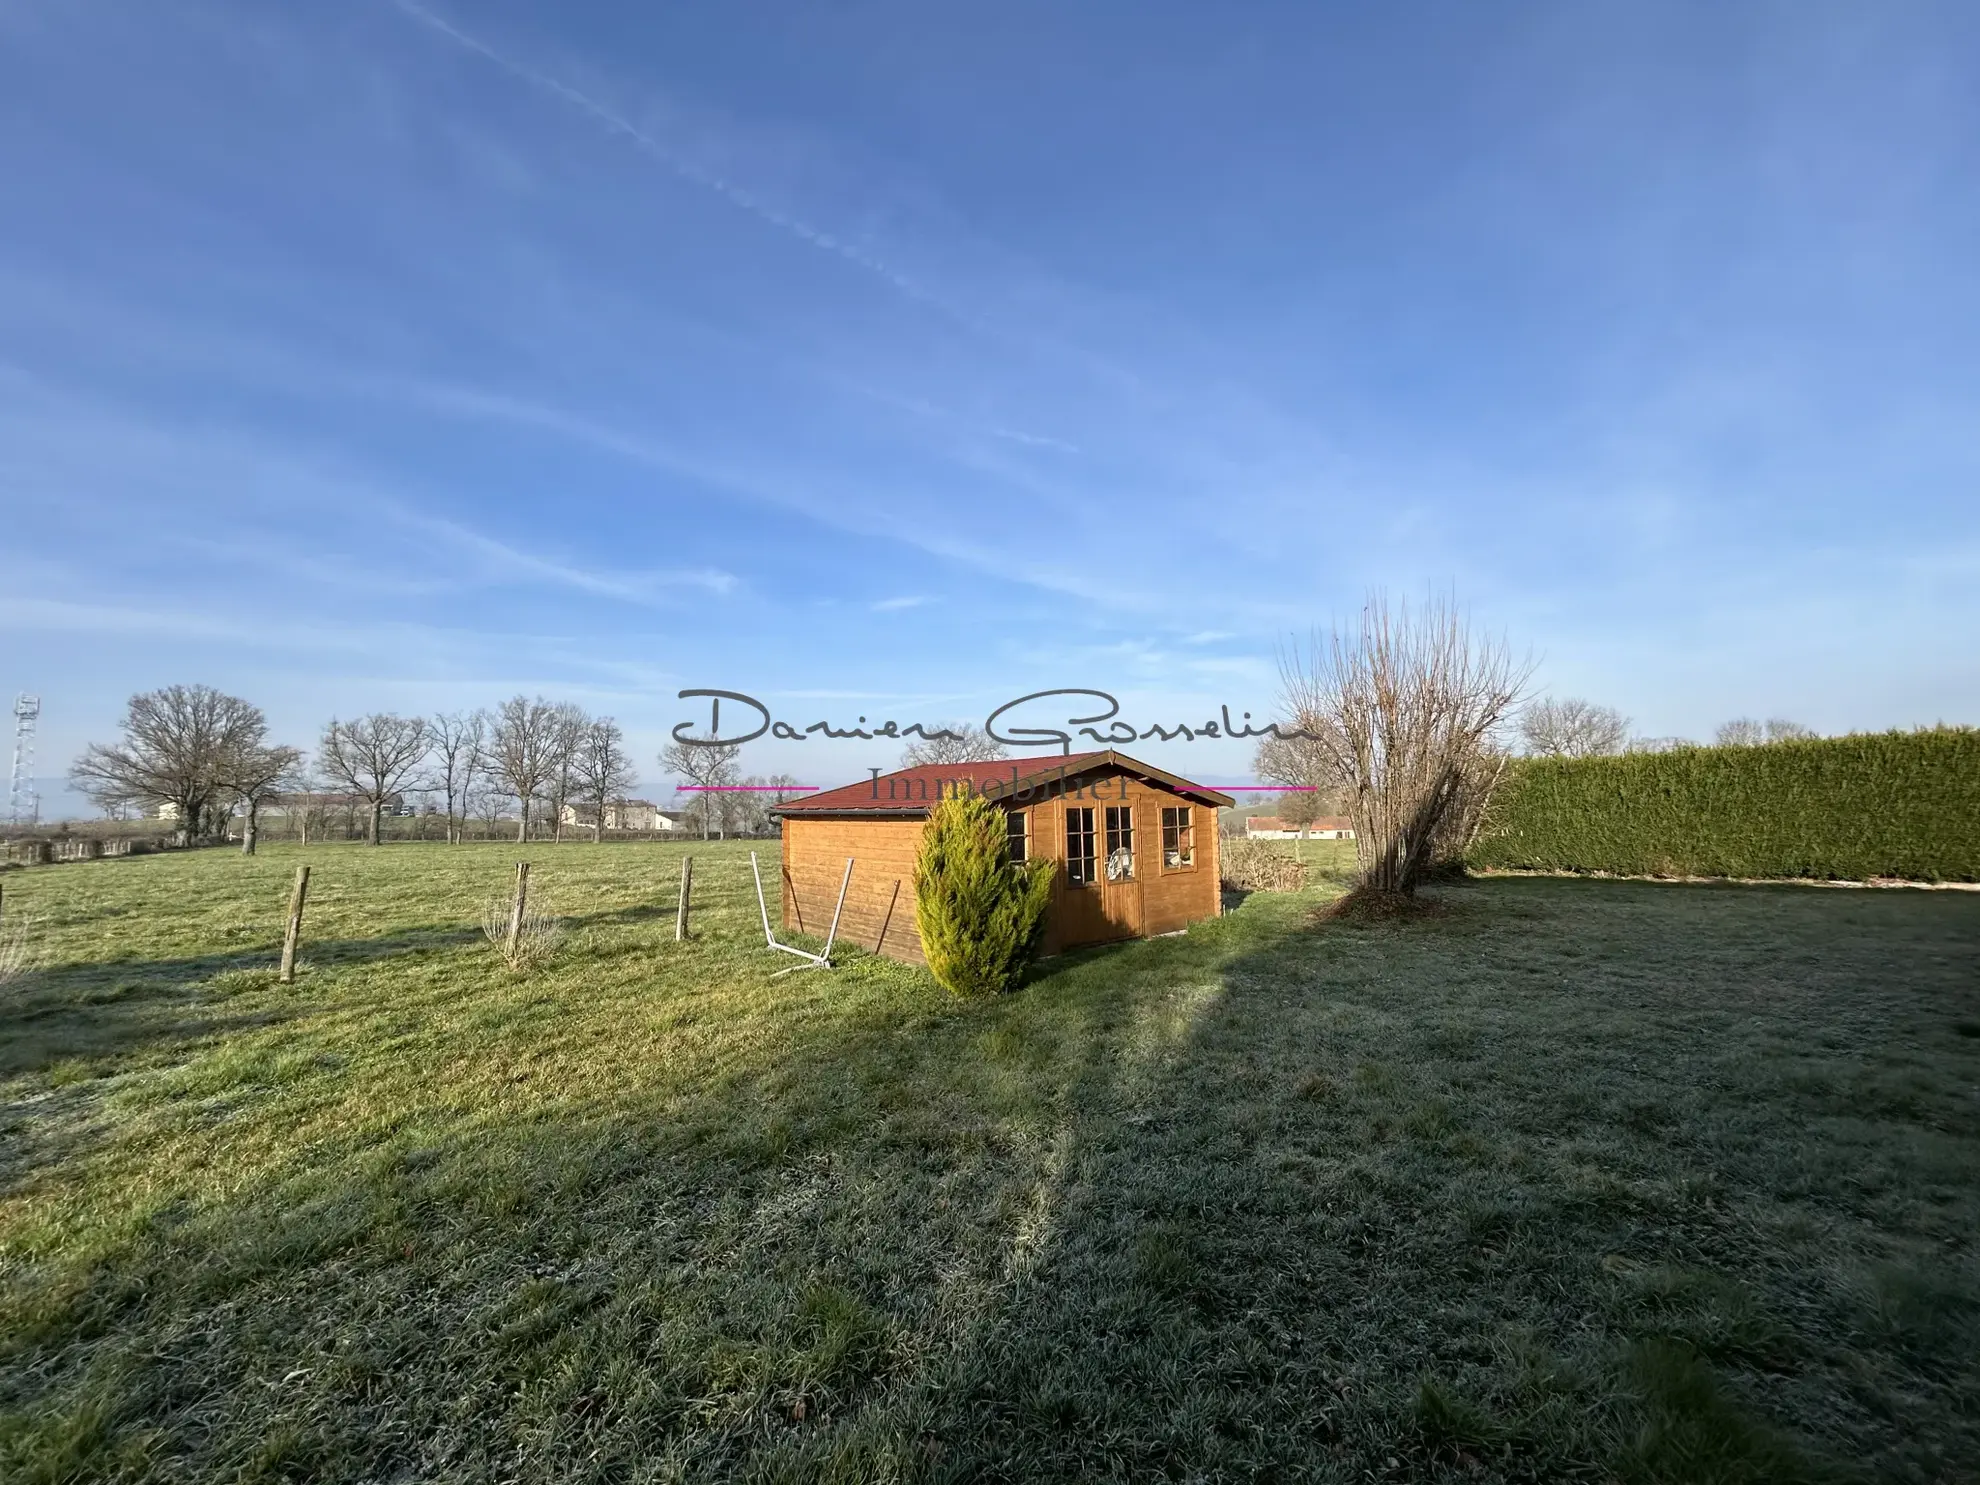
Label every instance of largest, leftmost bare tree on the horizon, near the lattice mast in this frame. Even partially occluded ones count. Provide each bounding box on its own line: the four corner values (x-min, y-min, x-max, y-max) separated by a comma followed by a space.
69, 685, 267, 843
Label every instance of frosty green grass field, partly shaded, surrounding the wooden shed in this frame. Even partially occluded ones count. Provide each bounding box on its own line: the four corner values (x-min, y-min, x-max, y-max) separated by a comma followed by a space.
0, 843, 1980, 1485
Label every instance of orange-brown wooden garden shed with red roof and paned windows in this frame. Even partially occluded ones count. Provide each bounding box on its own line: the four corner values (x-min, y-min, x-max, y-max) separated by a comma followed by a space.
774, 748, 1232, 964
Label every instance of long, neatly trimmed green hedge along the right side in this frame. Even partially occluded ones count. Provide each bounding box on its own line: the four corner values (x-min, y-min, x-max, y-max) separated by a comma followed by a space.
1465, 727, 1980, 881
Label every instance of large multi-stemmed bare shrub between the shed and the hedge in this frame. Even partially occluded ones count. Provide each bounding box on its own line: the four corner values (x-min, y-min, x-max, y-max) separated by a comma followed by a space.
1279, 598, 1533, 895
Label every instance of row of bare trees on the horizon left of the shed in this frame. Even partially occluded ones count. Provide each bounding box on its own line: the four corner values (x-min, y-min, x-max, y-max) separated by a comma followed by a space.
69, 685, 796, 853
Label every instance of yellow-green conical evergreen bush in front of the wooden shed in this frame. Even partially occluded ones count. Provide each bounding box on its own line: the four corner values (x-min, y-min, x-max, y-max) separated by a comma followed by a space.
915, 794, 1053, 996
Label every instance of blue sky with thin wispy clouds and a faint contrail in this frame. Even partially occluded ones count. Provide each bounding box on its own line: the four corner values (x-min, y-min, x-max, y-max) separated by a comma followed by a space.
0, 0, 1980, 815
